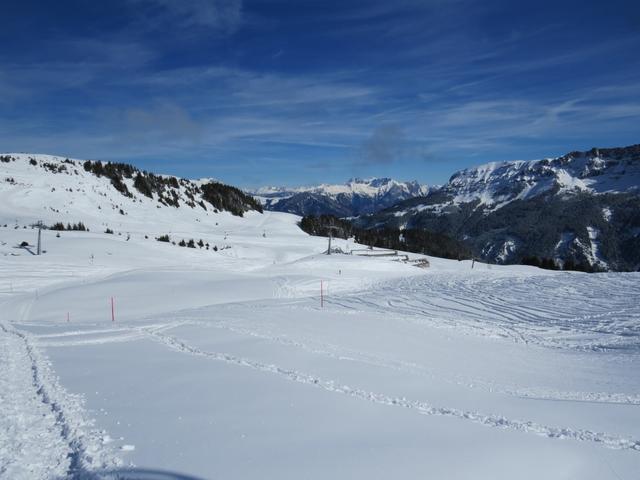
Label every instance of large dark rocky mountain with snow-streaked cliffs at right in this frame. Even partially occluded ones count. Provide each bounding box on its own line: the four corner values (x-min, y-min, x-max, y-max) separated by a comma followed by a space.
358, 145, 640, 270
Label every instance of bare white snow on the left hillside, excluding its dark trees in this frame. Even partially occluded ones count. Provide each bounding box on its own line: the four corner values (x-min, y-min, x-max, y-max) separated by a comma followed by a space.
0, 154, 257, 234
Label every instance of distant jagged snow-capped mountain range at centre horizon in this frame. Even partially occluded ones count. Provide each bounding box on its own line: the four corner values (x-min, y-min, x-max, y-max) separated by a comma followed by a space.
250, 178, 429, 217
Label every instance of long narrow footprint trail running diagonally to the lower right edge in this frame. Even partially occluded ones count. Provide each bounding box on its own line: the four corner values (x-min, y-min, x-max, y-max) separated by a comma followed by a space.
144, 331, 640, 451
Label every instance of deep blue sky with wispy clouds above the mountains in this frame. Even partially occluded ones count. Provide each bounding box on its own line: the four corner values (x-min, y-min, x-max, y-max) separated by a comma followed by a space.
0, 0, 640, 187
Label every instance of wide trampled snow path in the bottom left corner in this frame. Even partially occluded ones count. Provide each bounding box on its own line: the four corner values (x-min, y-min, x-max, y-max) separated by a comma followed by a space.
0, 324, 120, 480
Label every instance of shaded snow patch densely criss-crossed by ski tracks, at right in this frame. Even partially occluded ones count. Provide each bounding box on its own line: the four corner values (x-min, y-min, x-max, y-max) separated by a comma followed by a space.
326, 274, 640, 351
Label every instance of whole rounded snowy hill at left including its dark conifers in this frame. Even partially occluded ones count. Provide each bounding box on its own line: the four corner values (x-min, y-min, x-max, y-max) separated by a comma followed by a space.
0, 153, 262, 231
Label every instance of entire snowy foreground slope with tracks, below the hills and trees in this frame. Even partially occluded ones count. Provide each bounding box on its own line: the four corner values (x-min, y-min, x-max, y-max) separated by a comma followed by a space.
0, 213, 640, 479
